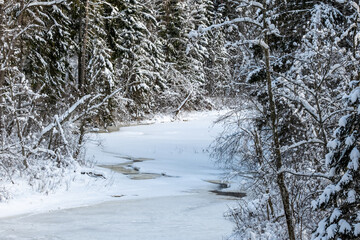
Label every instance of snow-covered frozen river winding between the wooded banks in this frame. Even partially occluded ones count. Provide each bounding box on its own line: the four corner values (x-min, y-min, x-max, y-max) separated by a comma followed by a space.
0, 112, 238, 240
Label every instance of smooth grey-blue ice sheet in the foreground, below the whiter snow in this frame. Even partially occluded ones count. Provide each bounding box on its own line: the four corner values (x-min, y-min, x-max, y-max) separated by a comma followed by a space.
0, 194, 231, 240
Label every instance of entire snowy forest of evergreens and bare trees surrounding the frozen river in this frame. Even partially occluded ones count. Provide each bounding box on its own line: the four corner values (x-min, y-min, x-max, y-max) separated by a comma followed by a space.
0, 0, 360, 240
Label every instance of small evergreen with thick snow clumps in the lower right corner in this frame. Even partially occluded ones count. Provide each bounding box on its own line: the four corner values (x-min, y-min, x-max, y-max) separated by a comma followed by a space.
313, 82, 360, 239
